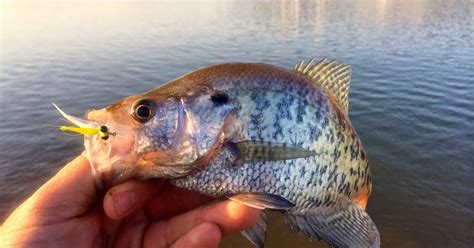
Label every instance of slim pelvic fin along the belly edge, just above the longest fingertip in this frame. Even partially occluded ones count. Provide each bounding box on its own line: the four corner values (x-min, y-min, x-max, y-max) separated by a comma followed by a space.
229, 193, 295, 210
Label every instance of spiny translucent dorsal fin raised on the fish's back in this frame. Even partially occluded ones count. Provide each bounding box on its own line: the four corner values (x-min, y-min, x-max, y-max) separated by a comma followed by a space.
293, 59, 351, 113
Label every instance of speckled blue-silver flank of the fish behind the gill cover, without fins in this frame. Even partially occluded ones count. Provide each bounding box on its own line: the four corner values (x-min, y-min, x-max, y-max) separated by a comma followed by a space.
173, 64, 371, 212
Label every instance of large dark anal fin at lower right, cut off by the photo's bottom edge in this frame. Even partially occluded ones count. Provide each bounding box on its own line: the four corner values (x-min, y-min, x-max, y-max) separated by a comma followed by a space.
285, 201, 380, 247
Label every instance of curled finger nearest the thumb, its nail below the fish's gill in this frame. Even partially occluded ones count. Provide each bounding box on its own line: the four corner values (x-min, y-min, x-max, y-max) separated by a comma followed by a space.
104, 179, 164, 219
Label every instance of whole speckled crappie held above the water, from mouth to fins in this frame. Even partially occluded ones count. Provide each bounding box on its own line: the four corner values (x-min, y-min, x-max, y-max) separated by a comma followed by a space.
58, 59, 380, 247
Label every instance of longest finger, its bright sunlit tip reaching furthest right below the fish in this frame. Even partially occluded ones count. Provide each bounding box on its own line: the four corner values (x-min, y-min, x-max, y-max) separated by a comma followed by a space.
144, 201, 259, 246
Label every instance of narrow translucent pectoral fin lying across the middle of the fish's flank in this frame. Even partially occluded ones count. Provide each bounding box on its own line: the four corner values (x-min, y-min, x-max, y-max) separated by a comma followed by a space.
229, 140, 316, 165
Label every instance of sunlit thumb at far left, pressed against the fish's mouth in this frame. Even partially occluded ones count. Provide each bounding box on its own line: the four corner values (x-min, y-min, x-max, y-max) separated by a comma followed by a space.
5, 155, 97, 225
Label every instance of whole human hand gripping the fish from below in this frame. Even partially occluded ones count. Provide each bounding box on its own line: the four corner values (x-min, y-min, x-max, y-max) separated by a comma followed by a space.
0, 156, 259, 247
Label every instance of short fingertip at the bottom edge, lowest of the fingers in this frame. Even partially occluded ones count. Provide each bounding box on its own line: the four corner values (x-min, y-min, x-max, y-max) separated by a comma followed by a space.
171, 222, 222, 248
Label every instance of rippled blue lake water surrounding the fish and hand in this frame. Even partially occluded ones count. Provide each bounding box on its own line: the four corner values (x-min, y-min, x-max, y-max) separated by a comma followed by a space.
0, 0, 474, 247
